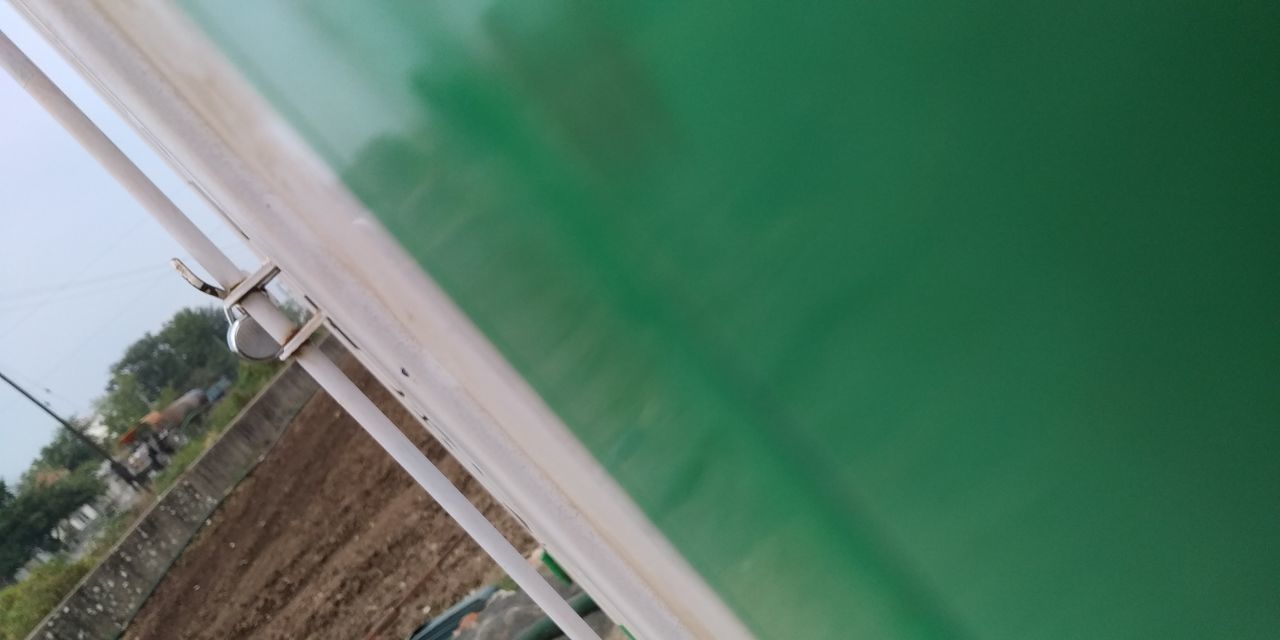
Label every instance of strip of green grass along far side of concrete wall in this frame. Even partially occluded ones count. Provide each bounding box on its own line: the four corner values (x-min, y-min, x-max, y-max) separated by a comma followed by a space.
0, 362, 279, 640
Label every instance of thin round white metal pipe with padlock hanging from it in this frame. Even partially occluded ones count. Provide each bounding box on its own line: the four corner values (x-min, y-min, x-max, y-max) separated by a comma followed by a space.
0, 26, 599, 640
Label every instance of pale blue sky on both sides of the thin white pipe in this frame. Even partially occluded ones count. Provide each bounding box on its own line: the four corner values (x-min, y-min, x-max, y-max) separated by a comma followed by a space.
0, 3, 257, 486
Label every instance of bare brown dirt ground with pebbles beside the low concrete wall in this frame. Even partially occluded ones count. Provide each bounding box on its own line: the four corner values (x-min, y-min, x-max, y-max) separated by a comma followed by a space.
124, 358, 534, 640
